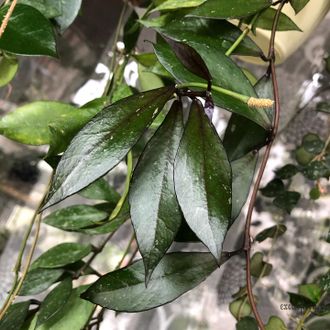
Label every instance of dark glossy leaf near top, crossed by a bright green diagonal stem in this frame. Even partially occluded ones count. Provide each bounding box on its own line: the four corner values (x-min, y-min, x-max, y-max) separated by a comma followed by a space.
157, 17, 260, 56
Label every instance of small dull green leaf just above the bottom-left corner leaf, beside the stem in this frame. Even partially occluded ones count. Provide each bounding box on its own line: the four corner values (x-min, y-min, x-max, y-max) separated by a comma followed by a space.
19, 268, 64, 296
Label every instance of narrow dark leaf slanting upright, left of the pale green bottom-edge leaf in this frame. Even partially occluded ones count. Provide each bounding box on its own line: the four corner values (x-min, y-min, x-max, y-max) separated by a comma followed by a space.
37, 278, 72, 327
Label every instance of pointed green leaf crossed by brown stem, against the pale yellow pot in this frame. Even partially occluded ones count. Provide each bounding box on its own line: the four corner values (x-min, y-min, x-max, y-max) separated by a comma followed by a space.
255, 8, 301, 31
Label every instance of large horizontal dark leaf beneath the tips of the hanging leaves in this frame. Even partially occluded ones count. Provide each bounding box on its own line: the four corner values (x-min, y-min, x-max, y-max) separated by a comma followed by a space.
82, 252, 222, 312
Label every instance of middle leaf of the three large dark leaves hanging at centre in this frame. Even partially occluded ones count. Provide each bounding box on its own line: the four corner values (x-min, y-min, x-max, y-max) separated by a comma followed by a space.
130, 101, 183, 280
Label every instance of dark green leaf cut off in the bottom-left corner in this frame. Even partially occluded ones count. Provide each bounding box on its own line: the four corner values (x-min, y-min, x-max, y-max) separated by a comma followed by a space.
0, 301, 30, 330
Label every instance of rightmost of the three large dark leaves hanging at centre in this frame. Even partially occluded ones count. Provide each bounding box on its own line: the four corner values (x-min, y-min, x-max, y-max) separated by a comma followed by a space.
174, 101, 231, 260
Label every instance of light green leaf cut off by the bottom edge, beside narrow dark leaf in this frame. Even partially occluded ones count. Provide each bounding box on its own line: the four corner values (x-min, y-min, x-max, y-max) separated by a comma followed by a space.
35, 286, 95, 330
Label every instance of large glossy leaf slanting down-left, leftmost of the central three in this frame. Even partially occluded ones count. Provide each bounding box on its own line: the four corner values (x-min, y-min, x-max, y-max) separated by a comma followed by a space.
44, 86, 174, 207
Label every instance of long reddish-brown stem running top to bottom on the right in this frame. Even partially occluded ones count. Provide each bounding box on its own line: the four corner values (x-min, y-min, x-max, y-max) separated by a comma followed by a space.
244, 0, 287, 330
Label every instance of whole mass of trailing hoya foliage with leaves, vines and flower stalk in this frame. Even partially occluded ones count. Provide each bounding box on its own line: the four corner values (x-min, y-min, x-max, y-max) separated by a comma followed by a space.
0, 0, 330, 330
